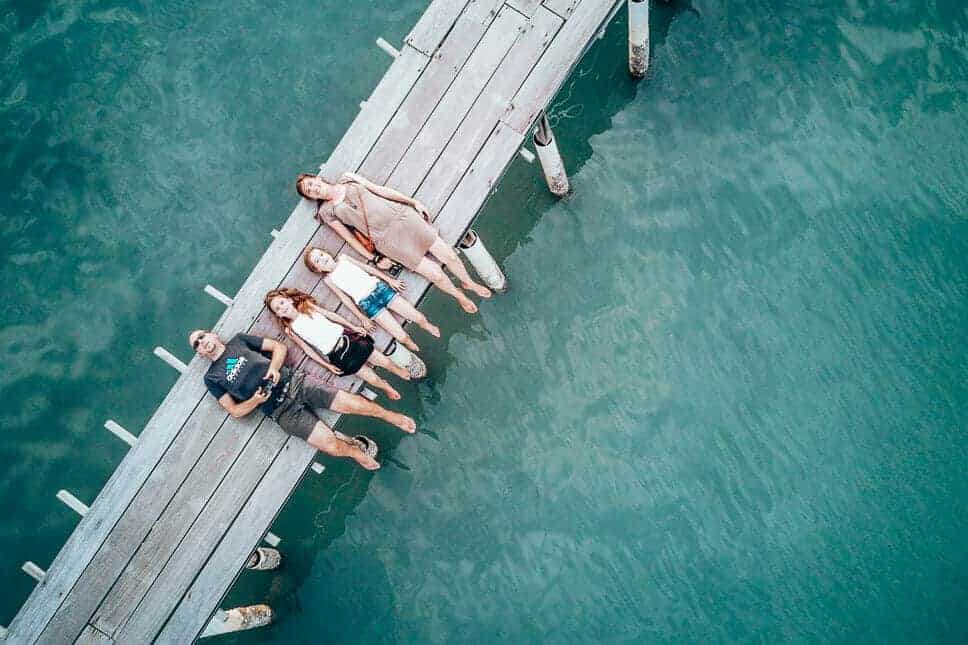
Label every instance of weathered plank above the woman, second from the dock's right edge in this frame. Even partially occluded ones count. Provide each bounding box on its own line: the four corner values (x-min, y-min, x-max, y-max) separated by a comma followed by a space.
417, 7, 562, 212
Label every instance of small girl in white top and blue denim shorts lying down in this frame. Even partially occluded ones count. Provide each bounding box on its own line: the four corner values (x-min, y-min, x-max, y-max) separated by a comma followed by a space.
303, 246, 440, 352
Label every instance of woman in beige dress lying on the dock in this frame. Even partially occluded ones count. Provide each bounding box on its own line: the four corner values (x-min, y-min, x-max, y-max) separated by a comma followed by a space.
296, 173, 491, 313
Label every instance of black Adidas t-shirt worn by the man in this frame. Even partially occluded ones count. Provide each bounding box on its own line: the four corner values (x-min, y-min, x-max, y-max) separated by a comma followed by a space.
205, 334, 289, 414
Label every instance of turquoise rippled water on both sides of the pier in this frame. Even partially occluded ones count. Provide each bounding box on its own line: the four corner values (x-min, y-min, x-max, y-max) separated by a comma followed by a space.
0, 0, 968, 643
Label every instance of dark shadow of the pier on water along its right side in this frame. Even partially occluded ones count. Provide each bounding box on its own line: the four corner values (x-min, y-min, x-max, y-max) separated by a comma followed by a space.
214, 10, 698, 642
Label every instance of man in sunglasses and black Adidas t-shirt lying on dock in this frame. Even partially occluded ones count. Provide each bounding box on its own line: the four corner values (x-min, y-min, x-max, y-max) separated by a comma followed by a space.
188, 329, 416, 470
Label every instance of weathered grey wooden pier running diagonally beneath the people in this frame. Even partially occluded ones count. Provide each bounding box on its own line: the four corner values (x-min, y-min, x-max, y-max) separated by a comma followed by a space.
7, 0, 647, 643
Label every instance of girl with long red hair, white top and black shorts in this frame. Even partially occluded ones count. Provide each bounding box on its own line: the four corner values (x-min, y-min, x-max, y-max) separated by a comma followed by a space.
265, 288, 410, 401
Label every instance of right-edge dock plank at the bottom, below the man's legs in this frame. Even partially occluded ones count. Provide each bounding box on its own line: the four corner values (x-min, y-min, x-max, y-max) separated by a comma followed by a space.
157, 438, 316, 644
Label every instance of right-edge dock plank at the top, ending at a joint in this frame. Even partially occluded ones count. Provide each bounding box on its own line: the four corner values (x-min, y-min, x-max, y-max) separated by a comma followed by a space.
503, 0, 620, 134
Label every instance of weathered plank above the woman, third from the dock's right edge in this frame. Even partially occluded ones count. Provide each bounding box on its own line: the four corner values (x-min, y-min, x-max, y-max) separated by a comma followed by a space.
389, 7, 528, 194
